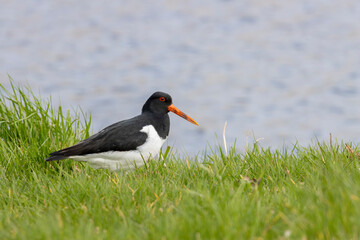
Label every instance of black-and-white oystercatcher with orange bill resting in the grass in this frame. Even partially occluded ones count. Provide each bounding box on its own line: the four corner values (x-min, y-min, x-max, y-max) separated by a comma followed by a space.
45, 91, 199, 171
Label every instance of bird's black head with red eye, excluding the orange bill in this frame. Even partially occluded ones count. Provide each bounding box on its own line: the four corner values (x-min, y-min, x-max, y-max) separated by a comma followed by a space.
142, 92, 172, 114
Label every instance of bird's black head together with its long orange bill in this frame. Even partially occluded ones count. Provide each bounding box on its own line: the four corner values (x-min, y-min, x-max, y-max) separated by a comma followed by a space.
142, 92, 199, 125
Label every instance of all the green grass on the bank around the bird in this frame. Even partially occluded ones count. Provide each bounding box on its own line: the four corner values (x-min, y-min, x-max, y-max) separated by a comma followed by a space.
0, 81, 360, 239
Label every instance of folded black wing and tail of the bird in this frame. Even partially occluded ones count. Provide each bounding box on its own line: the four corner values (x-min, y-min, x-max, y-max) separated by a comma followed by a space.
46, 115, 147, 161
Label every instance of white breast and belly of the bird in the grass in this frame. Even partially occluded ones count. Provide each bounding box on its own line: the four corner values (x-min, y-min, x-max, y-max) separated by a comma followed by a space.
71, 125, 166, 170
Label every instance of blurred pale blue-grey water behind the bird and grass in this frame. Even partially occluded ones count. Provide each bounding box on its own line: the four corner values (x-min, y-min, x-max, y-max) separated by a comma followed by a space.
0, 0, 360, 154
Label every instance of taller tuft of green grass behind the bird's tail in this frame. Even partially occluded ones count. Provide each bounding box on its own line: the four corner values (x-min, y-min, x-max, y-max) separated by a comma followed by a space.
0, 79, 90, 177
